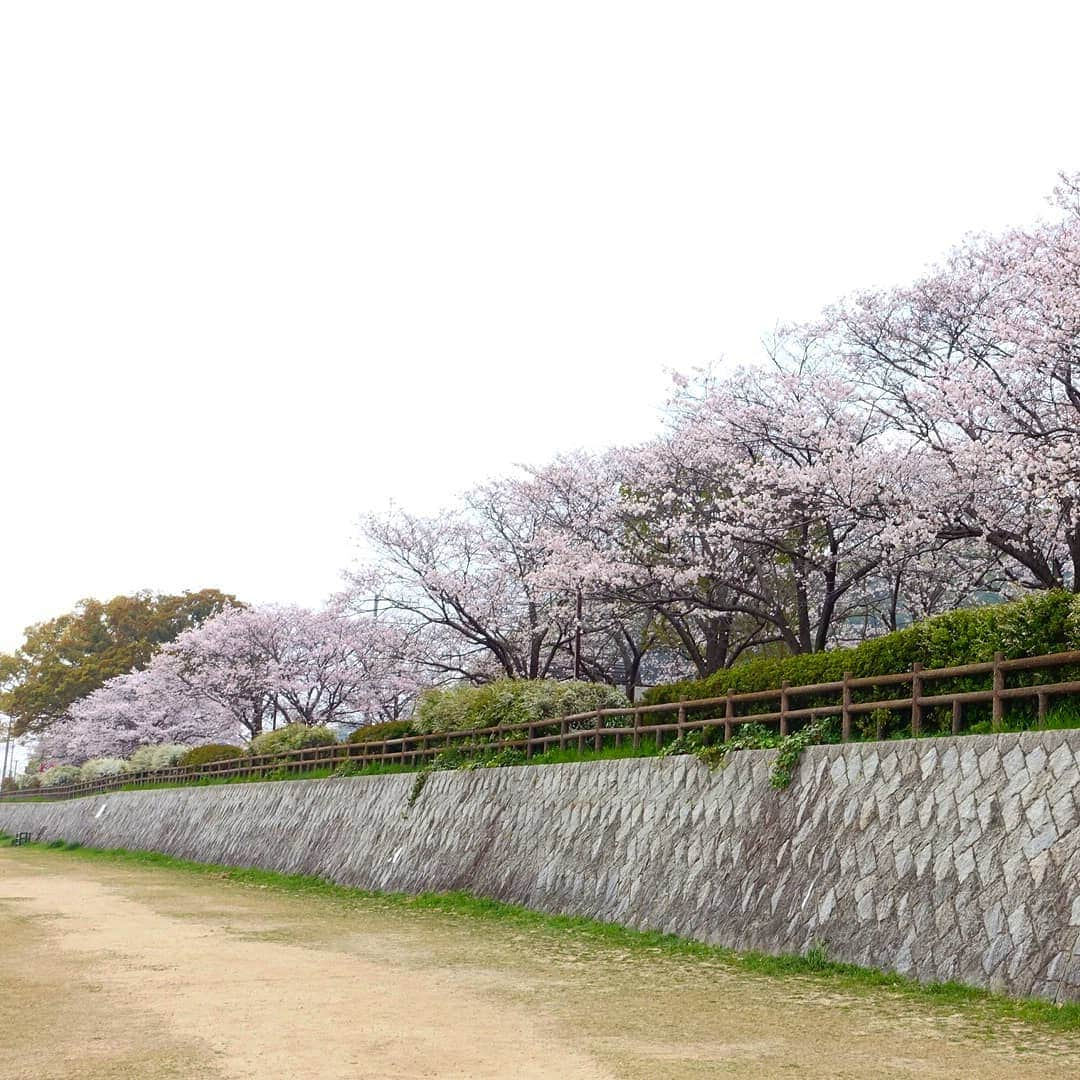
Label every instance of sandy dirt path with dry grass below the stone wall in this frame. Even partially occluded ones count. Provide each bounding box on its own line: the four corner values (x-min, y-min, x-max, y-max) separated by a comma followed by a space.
0, 849, 1080, 1080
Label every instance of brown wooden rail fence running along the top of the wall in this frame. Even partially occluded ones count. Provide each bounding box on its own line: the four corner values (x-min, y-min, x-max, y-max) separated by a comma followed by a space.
8, 651, 1080, 799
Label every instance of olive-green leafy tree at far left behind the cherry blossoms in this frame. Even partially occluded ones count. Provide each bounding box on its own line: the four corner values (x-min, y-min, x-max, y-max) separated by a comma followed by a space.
0, 589, 242, 735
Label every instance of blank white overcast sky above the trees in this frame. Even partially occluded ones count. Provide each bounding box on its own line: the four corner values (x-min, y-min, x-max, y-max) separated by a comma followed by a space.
0, 0, 1080, 649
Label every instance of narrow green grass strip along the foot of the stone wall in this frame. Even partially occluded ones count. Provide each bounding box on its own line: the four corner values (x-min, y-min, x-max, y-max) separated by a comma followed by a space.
0, 833, 1080, 1032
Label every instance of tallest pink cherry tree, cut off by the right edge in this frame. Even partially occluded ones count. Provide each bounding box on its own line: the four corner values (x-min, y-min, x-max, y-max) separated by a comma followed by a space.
800, 171, 1080, 589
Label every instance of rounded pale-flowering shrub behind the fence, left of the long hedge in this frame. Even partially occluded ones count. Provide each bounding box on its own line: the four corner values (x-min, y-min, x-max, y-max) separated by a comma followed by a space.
413, 678, 630, 734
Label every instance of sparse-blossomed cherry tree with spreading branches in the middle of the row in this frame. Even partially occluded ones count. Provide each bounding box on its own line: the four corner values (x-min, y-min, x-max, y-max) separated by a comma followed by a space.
346, 455, 691, 689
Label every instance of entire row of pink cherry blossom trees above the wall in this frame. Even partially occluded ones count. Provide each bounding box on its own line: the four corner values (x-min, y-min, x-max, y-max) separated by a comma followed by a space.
9, 170, 1080, 760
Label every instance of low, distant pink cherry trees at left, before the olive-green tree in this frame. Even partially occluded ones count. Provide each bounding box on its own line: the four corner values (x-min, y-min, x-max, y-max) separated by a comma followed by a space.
41, 606, 420, 764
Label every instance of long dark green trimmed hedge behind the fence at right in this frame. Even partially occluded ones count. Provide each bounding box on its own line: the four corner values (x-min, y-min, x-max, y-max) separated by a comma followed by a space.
644, 592, 1080, 726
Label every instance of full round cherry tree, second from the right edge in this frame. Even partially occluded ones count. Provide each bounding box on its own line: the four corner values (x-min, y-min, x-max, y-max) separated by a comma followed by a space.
600, 365, 946, 652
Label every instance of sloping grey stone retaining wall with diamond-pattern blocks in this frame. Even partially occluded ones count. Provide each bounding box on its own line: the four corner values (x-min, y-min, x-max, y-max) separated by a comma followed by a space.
0, 730, 1080, 1001
